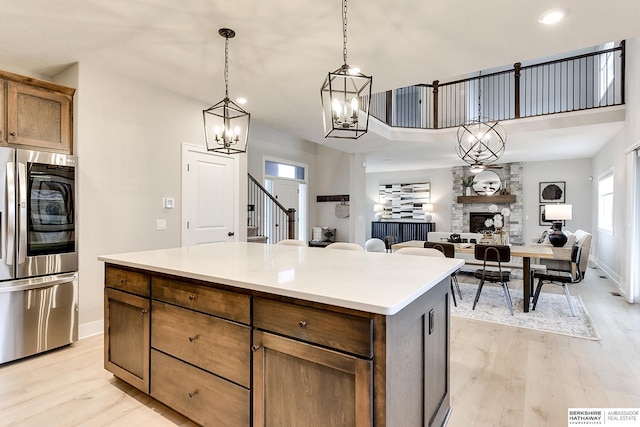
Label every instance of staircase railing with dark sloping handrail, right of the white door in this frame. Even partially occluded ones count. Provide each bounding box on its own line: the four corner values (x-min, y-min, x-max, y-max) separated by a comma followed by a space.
247, 174, 296, 243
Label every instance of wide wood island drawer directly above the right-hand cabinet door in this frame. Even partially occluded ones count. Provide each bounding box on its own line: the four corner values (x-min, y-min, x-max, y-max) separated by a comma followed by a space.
253, 298, 373, 357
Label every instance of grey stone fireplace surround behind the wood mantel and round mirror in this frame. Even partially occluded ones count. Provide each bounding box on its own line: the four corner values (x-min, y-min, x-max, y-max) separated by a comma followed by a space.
451, 163, 524, 245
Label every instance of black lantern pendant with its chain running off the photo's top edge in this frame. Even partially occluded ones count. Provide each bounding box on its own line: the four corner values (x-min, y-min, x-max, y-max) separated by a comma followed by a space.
320, 0, 372, 139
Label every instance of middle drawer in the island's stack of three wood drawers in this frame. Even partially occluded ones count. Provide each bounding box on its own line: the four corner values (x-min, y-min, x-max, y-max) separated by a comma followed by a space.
151, 301, 251, 388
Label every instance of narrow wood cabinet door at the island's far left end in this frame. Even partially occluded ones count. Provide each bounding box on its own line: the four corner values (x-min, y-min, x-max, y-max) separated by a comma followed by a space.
104, 288, 151, 393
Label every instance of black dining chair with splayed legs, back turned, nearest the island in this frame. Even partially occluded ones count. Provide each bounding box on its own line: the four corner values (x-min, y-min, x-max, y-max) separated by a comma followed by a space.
472, 245, 513, 316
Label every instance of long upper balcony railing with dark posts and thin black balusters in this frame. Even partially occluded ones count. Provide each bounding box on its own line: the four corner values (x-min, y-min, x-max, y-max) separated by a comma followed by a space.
370, 41, 625, 129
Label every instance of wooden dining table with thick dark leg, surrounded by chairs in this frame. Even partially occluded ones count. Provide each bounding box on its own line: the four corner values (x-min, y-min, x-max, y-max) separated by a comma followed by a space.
391, 240, 564, 313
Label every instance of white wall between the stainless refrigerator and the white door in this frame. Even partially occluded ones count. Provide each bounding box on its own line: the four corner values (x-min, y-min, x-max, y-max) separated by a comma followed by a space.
70, 62, 212, 336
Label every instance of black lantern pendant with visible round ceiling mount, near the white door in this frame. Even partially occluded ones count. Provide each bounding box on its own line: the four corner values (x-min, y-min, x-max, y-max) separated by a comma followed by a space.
202, 28, 251, 154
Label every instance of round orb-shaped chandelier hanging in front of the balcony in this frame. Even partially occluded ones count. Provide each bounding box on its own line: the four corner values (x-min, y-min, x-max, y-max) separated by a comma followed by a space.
456, 74, 507, 173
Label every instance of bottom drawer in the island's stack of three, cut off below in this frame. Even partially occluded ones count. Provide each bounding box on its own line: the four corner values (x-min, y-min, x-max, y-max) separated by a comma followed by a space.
151, 350, 251, 427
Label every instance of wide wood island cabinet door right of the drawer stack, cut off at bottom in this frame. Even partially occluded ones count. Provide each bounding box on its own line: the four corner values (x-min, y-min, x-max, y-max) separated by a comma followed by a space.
253, 331, 372, 427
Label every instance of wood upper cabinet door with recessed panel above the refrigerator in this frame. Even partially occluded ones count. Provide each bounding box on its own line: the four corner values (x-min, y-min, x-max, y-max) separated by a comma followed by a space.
7, 82, 72, 153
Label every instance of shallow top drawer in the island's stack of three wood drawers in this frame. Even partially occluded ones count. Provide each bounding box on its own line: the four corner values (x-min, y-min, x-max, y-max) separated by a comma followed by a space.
151, 276, 251, 325
